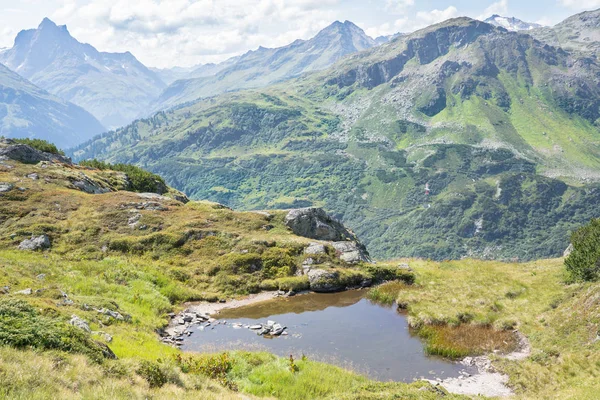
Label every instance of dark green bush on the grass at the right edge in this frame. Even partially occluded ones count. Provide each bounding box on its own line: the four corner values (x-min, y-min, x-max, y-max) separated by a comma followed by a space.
565, 219, 600, 281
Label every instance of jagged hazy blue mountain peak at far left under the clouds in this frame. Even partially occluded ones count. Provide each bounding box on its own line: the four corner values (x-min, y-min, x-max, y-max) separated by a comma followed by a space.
0, 18, 165, 128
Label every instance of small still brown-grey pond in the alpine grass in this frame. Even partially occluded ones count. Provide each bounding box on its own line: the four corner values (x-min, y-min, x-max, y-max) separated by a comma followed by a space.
182, 291, 472, 382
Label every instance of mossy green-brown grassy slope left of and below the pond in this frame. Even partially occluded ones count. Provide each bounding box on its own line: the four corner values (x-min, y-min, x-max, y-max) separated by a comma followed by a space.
0, 157, 450, 399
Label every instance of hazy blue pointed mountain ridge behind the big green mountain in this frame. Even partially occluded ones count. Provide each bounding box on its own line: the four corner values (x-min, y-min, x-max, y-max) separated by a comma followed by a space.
153, 21, 377, 111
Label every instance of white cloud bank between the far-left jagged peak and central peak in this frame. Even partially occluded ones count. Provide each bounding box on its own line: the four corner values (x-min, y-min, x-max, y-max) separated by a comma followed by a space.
51, 0, 342, 67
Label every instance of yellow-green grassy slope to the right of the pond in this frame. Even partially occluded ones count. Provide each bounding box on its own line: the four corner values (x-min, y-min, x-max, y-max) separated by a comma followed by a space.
374, 259, 600, 399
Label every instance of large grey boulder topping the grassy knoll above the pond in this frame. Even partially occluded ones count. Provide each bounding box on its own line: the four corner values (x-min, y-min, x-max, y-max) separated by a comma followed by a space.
285, 207, 356, 241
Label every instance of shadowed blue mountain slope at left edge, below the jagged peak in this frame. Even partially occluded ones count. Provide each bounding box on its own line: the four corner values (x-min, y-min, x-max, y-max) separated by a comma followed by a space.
0, 64, 104, 147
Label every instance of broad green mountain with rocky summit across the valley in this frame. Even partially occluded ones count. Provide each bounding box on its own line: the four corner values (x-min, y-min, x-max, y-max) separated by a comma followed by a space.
73, 18, 600, 259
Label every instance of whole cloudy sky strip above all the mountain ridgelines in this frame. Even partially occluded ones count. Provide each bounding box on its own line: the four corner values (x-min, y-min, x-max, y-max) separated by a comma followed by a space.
0, 0, 600, 68
